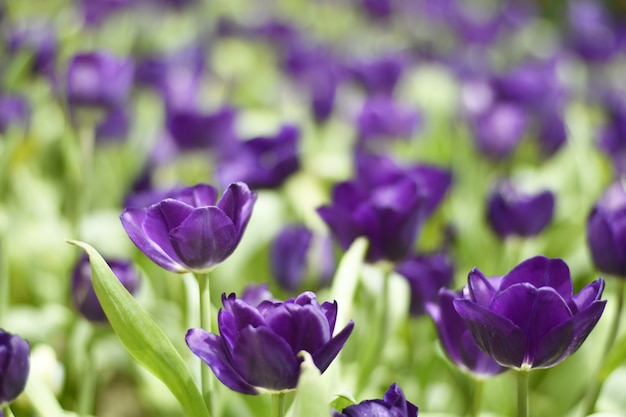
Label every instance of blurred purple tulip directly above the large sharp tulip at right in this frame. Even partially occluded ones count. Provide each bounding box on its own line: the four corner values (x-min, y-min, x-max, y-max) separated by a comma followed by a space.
487, 181, 555, 239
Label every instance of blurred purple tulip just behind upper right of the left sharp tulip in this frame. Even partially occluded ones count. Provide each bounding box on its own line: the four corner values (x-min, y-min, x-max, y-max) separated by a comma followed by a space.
218, 125, 300, 190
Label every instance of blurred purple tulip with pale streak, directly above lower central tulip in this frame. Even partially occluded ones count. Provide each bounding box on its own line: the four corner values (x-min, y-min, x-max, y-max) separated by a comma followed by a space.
270, 225, 336, 291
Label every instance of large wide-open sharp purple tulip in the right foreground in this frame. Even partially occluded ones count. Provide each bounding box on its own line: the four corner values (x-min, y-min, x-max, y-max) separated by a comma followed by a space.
453, 256, 606, 369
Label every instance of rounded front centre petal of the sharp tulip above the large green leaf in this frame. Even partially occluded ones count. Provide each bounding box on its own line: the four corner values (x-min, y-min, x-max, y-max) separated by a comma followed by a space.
169, 206, 238, 269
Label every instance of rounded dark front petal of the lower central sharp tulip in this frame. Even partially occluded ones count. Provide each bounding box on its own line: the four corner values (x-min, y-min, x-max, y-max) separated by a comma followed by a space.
232, 327, 300, 391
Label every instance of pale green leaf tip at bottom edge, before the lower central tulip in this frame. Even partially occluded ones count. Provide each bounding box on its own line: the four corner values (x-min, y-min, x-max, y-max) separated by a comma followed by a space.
288, 351, 330, 417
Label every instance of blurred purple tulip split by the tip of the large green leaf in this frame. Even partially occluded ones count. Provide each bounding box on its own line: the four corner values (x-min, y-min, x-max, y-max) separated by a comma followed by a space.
72, 256, 140, 323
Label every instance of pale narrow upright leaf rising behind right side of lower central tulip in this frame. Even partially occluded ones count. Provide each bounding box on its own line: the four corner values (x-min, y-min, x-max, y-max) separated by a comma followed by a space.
330, 237, 367, 326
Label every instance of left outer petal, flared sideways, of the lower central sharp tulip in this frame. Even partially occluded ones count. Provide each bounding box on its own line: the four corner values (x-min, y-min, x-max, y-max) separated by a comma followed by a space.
185, 329, 259, 395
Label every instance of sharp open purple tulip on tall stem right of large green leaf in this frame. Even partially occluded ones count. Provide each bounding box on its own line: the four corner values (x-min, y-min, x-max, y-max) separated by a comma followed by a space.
121, 183, 257, 273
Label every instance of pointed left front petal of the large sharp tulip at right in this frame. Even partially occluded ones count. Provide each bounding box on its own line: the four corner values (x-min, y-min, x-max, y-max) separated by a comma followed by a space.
454, 299, 526, 368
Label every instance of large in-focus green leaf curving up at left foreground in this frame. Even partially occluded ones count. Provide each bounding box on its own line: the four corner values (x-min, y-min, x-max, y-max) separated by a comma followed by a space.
68, 241, 209, 417
